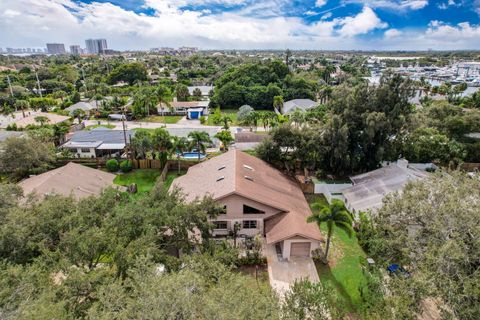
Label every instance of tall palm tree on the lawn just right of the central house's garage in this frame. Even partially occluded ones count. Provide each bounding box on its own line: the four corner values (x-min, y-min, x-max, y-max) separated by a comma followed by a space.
307, 199, 353, 263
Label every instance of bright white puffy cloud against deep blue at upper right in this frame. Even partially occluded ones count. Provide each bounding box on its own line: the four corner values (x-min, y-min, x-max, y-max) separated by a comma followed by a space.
338, 7, 388, 37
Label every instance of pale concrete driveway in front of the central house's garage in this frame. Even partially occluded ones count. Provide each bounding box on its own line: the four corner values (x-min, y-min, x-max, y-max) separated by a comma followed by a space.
264, 244, 320, 298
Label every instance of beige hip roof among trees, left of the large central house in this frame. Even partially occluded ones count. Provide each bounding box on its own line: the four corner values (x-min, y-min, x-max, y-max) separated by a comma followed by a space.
18, 162, 121, 199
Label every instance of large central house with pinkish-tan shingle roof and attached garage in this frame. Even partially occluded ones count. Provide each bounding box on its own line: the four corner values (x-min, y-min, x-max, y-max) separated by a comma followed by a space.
171, 150, 323, 259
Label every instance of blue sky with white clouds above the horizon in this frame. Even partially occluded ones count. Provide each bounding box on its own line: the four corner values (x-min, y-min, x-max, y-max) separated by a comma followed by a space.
0, 0, 480, 50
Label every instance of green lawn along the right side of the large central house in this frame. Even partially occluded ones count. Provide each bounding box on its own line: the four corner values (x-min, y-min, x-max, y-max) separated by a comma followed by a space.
307, 195, 366, 313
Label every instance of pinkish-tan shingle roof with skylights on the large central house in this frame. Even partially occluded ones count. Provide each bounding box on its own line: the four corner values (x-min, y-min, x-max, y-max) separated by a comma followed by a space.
171, 150, 323, 243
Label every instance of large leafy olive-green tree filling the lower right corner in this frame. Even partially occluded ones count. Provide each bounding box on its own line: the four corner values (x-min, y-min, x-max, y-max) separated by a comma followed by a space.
364, 171, 480, 319
